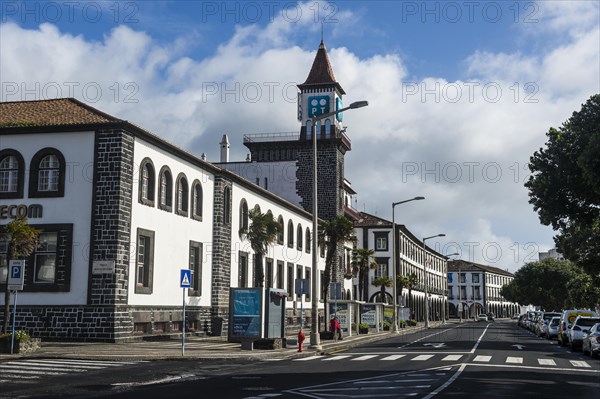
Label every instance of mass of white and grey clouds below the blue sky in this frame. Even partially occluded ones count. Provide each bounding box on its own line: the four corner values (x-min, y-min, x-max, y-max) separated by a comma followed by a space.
0, 2, 600, 271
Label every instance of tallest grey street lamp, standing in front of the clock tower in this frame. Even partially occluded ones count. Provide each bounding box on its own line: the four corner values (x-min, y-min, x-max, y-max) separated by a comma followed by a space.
310, 101, 369, 350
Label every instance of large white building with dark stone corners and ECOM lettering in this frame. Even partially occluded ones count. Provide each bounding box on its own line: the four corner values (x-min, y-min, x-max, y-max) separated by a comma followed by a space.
0, 99, 323, 341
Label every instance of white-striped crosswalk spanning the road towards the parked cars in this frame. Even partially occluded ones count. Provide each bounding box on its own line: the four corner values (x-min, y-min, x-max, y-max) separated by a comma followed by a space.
293, 354, 592, 369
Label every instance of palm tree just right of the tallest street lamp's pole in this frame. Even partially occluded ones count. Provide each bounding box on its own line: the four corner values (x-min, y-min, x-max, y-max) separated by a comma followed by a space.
319, 216, 356, 299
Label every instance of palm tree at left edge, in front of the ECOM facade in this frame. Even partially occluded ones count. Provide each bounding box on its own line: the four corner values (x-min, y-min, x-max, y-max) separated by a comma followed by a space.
0, 217, 40, 334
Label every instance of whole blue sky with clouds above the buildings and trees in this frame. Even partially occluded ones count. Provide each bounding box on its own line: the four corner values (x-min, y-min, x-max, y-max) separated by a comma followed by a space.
0, 0, 600, 272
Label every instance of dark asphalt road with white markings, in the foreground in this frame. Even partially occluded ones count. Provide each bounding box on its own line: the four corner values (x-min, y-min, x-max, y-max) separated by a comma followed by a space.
0, 320, 600, 399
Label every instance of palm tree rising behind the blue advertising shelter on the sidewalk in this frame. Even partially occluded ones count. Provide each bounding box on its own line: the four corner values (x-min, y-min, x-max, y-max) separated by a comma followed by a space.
240, 208, 283, 288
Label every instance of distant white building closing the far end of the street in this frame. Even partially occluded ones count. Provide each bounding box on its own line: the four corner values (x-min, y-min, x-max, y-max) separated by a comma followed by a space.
448, 260, 520, 319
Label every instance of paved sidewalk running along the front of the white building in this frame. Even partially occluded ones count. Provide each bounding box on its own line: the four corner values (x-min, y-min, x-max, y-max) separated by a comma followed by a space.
0, 326, 432, 362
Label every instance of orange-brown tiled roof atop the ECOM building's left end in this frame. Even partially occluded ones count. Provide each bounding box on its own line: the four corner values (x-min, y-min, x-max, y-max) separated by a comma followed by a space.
0, 98, 123, 127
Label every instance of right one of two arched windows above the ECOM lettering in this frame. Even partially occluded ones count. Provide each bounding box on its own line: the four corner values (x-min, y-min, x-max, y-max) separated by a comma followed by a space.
29, 148, 65, 197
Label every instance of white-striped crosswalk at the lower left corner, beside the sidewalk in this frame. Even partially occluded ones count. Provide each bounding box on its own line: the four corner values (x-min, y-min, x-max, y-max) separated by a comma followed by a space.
0, 359, 140, 383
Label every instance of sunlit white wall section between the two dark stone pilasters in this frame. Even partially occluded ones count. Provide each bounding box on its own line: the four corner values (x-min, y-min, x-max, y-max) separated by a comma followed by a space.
128, 138, 214, 306
